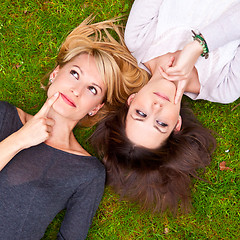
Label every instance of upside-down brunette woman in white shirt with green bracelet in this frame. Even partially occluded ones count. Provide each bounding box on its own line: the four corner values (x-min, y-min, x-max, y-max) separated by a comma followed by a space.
92, 0, 240, 211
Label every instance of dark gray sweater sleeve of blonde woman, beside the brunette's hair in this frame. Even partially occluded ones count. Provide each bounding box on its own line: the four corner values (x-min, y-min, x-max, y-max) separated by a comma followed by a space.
57, 166, 105, 240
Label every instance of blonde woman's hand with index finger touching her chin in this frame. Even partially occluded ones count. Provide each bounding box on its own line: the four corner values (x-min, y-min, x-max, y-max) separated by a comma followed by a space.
16, 93, 59, 149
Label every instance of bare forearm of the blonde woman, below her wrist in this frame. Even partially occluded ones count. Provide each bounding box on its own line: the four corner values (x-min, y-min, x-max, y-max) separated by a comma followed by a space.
0, 132, 24, 171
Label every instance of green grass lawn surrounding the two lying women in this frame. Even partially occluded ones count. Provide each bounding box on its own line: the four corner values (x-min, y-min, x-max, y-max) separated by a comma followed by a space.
0, 0, 240, 240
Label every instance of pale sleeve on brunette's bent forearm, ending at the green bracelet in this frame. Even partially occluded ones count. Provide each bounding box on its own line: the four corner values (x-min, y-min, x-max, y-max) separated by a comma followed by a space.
202, 2, 240, 51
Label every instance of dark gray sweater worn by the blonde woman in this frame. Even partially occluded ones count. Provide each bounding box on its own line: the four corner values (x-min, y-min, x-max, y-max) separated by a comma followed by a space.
0, 101, 105, 240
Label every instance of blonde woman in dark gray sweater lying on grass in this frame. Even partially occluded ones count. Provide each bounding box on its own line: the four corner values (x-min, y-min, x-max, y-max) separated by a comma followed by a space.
0, 19, 146, 240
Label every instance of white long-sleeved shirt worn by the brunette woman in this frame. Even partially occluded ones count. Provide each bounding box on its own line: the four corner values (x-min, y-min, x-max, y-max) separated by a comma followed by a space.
125, 0, 240, 103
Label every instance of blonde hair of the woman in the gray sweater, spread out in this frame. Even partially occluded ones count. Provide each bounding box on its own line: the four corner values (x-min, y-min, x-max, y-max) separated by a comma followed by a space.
42, 16, 148, 126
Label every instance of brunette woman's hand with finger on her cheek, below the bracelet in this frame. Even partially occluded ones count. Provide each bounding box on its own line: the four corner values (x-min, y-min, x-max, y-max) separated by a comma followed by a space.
159, 41, 203, 104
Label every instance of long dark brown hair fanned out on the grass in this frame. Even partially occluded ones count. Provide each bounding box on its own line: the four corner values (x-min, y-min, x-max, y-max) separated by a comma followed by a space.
91, 102, 215, 212
